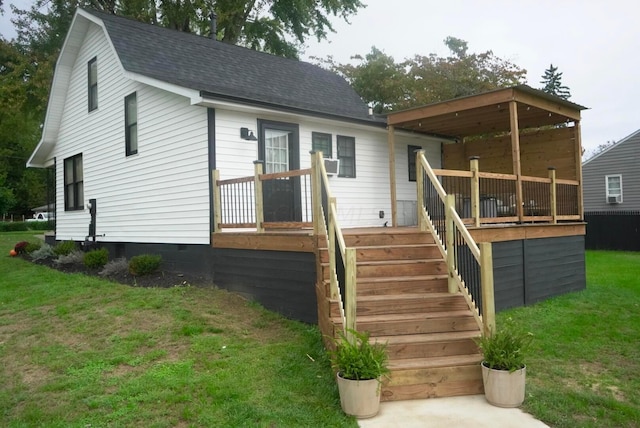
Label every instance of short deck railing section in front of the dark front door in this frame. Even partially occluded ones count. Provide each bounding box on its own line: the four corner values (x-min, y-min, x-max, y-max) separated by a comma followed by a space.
212, 161, 313, 233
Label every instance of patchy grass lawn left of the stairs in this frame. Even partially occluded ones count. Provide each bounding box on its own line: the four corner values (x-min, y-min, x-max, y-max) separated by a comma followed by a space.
0, 232, 357, 427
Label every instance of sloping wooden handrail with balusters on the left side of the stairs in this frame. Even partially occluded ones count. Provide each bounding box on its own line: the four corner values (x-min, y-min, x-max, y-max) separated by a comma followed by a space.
311, 152, 357, 340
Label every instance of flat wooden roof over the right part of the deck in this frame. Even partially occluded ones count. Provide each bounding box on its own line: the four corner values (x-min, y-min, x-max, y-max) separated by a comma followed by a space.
387, 85, 586, 138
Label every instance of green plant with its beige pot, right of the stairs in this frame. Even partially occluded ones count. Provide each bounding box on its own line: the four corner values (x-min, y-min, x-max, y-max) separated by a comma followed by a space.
477, 318, 532, 407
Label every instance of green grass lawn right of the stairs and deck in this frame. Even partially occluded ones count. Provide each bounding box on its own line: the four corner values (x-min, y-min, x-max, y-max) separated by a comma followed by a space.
498, 251, 640, 427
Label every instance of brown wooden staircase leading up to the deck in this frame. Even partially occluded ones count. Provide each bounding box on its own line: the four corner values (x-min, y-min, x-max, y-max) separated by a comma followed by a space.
316, 228, 483, 401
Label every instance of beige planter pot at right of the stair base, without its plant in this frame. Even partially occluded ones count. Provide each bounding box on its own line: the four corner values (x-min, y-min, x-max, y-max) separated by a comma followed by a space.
481, 364, 527, 407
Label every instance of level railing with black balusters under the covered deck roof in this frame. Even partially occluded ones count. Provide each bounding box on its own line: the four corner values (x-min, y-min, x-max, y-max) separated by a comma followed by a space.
433, 158, 582, 227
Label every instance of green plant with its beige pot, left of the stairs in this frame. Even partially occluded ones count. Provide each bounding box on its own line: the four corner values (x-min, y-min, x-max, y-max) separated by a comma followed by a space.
330, 330, 389, 418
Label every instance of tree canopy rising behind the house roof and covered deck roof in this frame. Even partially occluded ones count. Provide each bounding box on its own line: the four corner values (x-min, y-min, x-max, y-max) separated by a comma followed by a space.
324, 37, 526, 113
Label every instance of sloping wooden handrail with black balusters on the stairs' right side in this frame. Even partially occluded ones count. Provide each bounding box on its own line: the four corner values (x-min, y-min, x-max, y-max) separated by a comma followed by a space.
416, 150, 495, 334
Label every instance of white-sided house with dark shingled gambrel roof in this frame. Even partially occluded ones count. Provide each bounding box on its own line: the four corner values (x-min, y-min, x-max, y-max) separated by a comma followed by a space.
28, 10, 443, 273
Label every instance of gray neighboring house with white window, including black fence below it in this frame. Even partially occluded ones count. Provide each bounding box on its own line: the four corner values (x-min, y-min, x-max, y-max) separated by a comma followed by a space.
582, 130, 640, 251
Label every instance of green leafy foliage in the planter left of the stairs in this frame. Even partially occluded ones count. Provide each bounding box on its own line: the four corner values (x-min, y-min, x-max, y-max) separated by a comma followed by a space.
329, 330, 389, 380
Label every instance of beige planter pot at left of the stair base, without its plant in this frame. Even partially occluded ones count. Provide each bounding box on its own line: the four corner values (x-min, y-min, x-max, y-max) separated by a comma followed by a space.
337, 373, 380, 419
